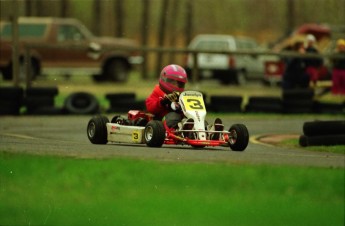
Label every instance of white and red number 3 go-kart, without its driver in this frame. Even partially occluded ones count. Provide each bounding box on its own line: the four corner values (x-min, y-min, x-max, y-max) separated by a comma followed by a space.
87, 91, 249, 151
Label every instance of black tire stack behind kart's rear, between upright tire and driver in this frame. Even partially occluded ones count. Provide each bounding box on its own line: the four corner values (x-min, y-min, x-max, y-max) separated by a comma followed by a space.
105, 93, 145, 113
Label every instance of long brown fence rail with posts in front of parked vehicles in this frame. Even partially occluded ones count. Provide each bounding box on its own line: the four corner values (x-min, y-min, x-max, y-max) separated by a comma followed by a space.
24, 44, 344, 87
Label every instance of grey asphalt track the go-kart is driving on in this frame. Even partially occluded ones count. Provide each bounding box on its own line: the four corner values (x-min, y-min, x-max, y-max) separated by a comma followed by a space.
0, 116, 345, 168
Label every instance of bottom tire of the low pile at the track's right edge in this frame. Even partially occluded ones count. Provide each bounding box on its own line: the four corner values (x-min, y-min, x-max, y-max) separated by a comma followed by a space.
299, 134, 345, 147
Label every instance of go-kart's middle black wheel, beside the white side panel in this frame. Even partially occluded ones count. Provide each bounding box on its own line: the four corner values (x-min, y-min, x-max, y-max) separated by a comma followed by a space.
144, 120, 165, 147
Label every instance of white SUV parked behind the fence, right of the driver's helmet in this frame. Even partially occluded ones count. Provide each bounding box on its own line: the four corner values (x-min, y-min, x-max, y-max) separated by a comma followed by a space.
186, 34, 264, 84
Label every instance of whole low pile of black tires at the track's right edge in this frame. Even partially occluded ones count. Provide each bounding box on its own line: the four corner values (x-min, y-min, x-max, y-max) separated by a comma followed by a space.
299, 120, 345, 147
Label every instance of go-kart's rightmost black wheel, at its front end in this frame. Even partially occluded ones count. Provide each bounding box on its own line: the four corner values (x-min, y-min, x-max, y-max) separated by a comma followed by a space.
228, 124, 249, 151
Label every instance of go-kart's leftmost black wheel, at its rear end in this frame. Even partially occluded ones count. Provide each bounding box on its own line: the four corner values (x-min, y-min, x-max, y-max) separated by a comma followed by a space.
87, 115, 109, 144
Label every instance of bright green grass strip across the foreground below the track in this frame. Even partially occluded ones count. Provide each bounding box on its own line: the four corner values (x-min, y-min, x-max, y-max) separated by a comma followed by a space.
0, 151, 344, 226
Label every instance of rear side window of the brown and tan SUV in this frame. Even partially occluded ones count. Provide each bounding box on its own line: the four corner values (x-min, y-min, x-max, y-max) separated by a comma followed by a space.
0, 24, 47, 38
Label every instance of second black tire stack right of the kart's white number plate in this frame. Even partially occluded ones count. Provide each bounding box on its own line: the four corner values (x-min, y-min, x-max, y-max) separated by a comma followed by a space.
245, 97, 283, 113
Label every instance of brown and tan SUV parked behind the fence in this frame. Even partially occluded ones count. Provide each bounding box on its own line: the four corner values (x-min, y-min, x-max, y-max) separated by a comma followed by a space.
0, 17, 142, 82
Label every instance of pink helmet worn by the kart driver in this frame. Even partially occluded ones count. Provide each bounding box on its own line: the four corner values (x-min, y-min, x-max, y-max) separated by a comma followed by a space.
159, 64, 187, 94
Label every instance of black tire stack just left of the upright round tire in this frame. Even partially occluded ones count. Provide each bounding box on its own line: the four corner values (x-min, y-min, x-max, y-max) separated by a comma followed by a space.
24, 87, 62, 115
